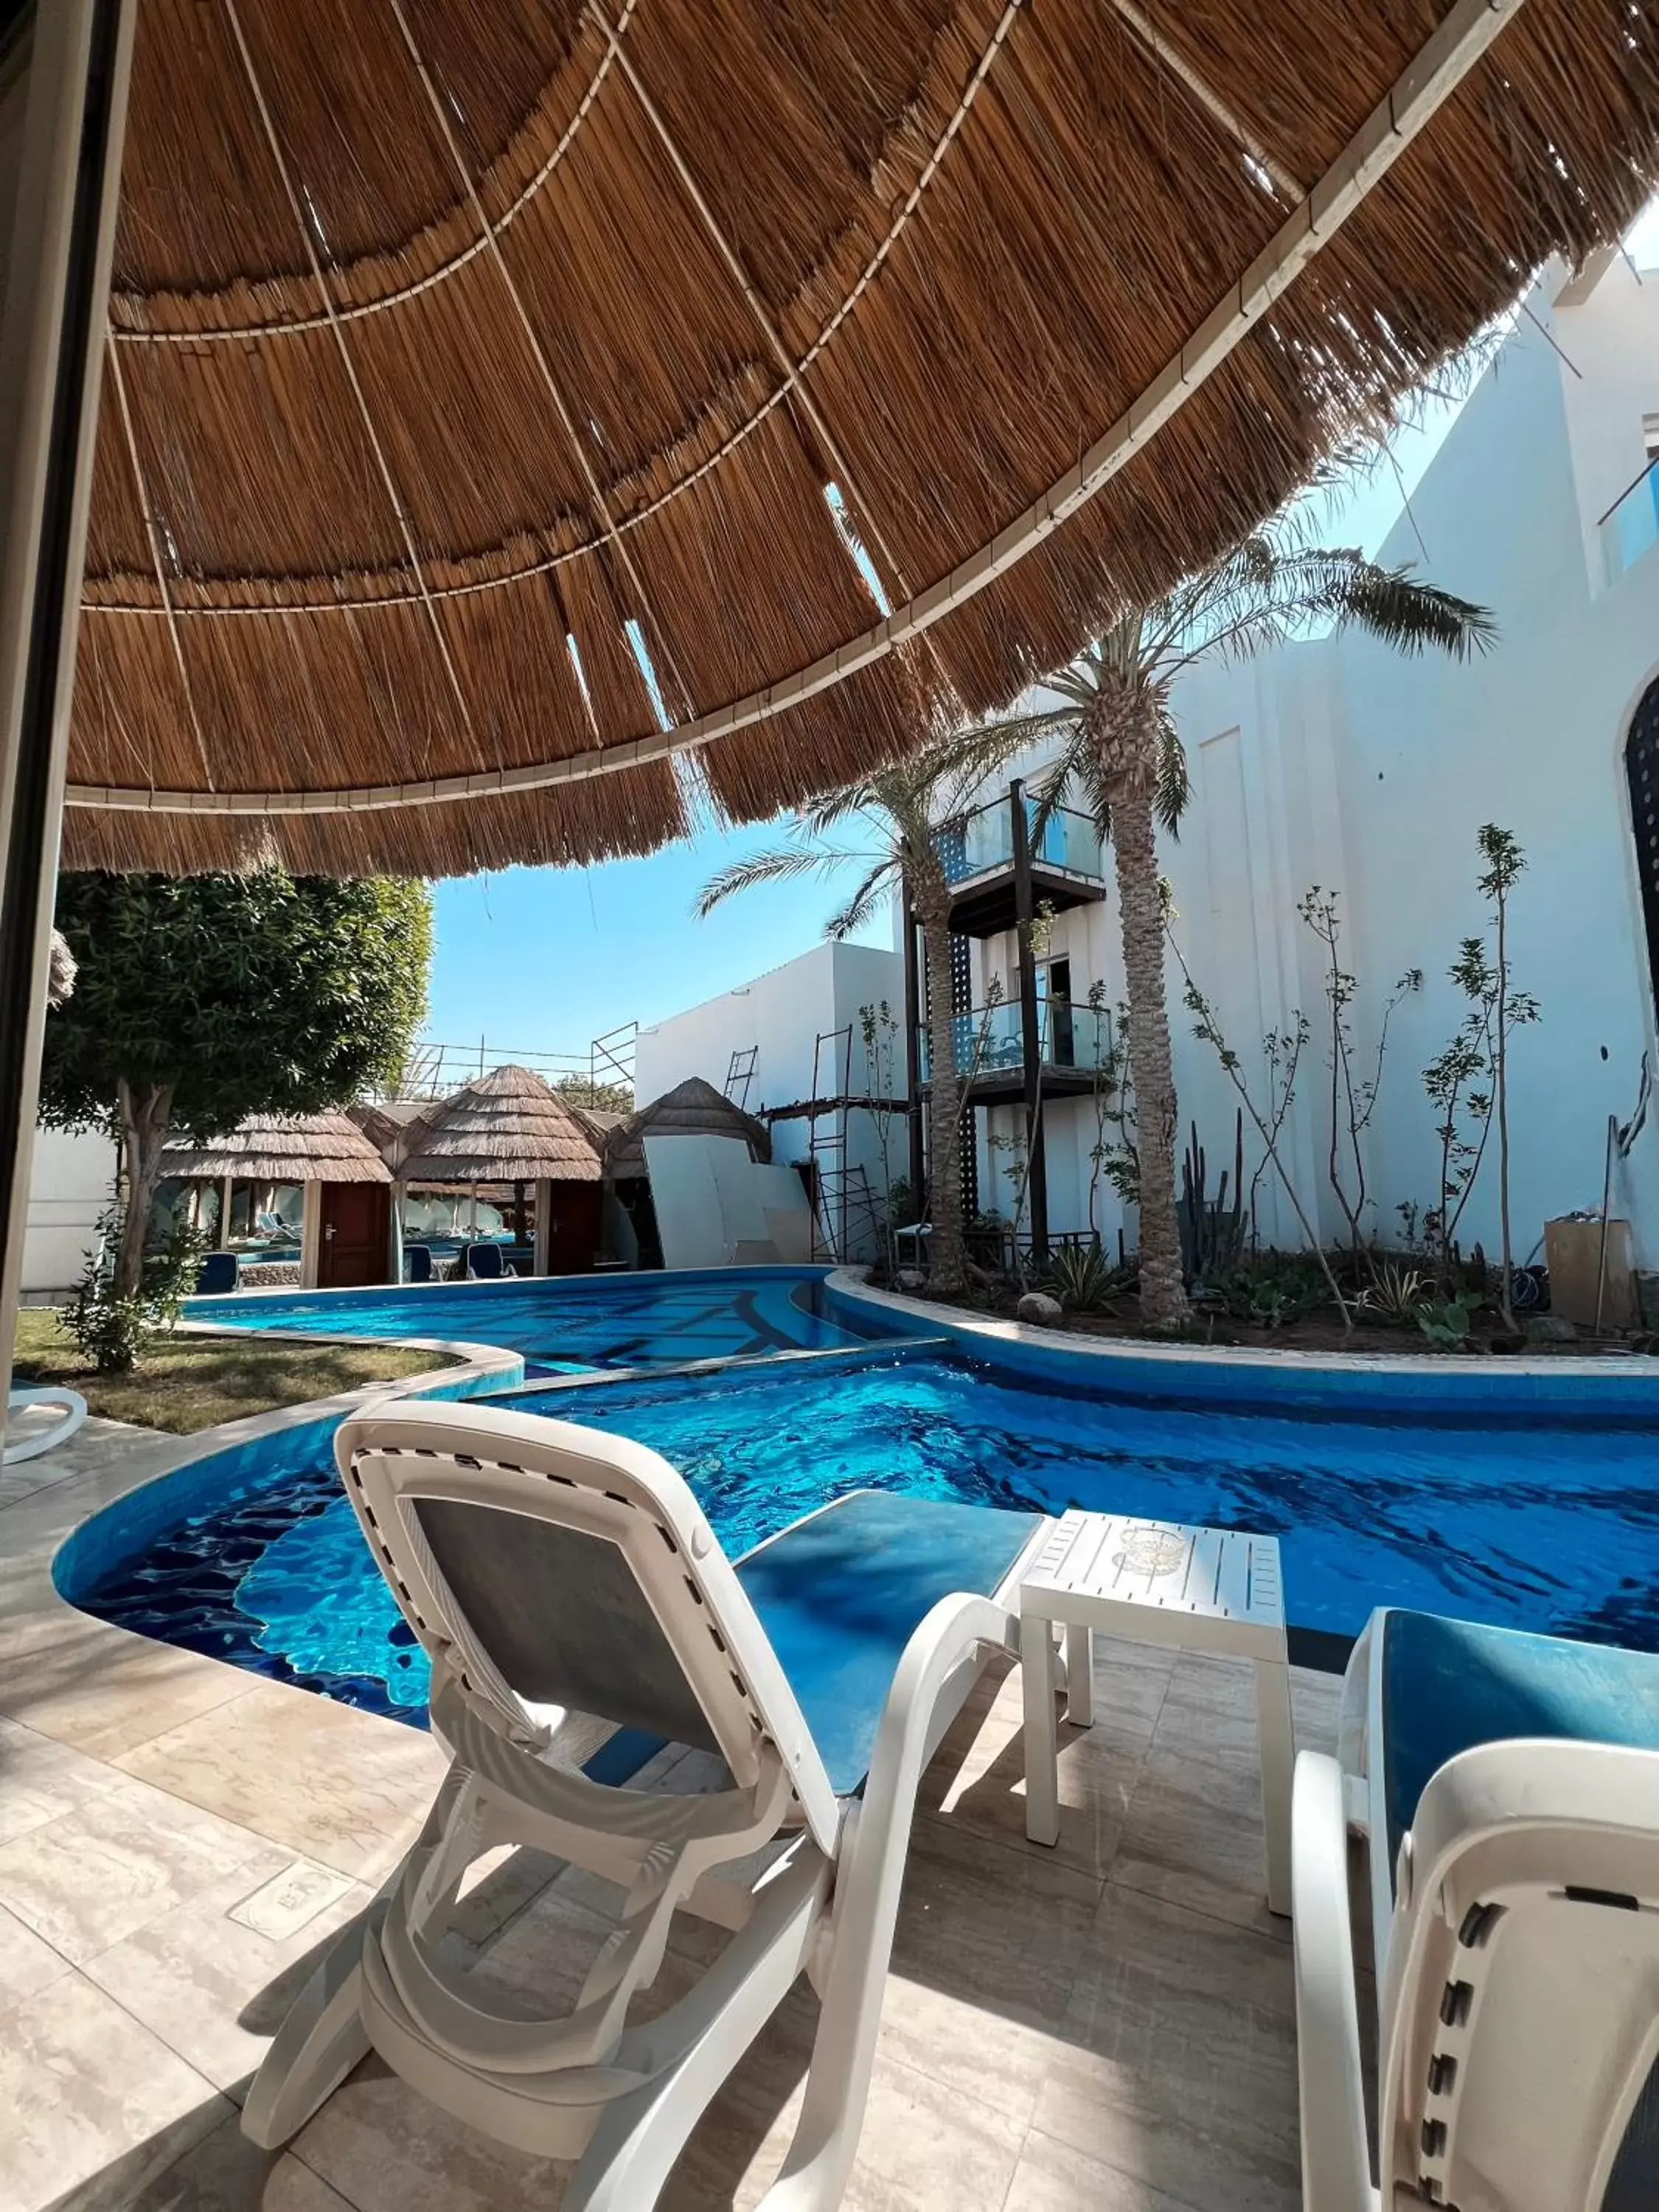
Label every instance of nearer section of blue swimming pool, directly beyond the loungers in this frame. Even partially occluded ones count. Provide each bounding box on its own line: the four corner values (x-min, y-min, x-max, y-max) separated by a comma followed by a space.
60, 1318, 1659, 1719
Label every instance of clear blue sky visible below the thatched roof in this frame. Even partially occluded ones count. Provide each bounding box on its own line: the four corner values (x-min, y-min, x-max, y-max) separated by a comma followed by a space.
425, 383, 1458, 1060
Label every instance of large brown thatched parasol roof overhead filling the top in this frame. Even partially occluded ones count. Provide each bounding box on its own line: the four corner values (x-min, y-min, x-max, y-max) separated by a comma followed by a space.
66, 0, 1659, 874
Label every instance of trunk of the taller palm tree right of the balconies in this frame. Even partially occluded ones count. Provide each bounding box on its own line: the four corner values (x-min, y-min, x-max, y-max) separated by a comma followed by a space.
1091, 692, 1188, 1329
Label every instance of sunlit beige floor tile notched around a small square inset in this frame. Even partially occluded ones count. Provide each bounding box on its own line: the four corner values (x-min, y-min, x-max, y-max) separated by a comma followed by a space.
84, 1847, 372, 2097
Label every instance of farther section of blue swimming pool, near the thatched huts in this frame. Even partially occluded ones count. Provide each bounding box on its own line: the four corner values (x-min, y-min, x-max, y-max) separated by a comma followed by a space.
186, 1267, 874, 1374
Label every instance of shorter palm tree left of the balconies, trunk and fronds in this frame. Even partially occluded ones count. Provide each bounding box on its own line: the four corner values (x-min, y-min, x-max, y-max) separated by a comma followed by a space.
695, 723, 1018, 1296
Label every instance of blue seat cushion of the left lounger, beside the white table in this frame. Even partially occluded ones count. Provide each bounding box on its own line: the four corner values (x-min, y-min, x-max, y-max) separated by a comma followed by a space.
737, 1491, 1042, 1796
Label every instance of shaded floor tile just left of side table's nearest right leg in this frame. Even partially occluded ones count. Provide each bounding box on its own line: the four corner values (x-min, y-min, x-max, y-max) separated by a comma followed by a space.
1108, 1743, 1290, 1944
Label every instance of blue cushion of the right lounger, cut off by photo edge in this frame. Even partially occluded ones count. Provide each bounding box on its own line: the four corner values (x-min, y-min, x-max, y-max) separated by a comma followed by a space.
1374, 1610, 1659, 1865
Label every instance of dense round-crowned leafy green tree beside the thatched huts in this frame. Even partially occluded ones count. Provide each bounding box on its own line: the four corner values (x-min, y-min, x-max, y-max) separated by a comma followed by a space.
40, 869, 431, 1296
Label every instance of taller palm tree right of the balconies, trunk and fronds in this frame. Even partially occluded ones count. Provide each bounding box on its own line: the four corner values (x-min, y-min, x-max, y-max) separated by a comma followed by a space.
995, 540, 1498, 1327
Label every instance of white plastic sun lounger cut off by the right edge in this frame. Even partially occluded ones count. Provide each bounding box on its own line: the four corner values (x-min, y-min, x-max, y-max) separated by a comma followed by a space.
1292, 1610, 1659, 2212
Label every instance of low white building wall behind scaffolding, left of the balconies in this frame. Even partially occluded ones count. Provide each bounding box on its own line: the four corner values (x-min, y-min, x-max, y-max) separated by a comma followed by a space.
635, 942, 909, 1248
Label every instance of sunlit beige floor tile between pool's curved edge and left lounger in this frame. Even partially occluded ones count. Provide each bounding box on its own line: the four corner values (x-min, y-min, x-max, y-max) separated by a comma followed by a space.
119, 1677, 447, 1882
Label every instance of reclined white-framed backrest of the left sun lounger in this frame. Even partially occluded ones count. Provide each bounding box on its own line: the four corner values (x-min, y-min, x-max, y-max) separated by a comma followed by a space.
334, 1405, 838, 1849
